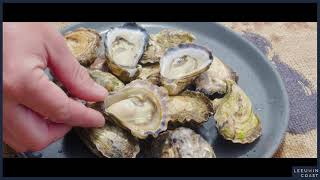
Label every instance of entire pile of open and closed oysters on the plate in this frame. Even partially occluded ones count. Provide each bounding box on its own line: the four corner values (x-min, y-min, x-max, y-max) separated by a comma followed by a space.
64, 23, 261, 158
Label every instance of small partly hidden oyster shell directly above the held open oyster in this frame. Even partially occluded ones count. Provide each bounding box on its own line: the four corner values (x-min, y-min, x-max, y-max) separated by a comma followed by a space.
137, 63, 160, 85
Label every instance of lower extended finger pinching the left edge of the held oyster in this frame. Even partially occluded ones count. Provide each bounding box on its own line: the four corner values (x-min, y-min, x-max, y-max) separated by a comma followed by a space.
10, 69, 105, 127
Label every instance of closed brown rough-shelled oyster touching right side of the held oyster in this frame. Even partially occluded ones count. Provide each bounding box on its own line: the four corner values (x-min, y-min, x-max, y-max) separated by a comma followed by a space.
168, 91, 213, 125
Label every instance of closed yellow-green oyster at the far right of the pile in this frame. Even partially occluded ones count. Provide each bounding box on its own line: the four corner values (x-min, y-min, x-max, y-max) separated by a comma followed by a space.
214, 80, 261, 144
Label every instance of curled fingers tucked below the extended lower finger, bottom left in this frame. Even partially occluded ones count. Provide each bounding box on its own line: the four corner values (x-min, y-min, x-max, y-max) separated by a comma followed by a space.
5, 101, 71, 152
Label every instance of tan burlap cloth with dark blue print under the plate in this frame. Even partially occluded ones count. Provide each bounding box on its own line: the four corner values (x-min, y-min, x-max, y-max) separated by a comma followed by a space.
4, 22, 317, 158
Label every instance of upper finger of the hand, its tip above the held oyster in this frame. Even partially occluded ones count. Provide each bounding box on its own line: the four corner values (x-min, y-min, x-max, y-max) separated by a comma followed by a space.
42, 24, 107, 101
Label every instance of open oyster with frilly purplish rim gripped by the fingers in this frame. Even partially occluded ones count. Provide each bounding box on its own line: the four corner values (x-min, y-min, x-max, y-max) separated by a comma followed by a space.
104, 80, 168, 139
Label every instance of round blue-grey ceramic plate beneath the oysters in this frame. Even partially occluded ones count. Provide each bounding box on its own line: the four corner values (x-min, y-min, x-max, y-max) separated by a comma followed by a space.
17, 22, 289, 158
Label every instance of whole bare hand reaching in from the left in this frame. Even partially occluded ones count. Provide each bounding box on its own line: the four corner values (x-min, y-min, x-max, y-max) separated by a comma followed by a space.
3, 22, 108, 152
